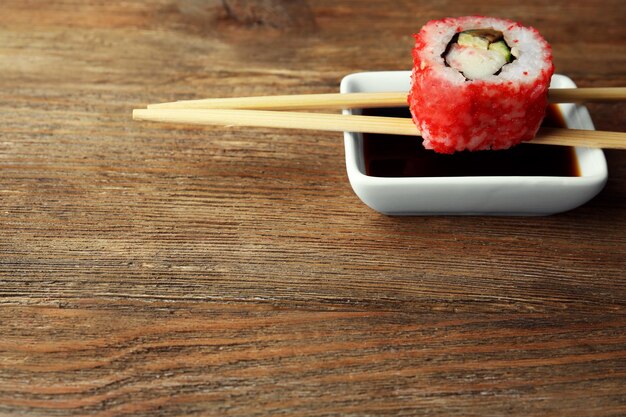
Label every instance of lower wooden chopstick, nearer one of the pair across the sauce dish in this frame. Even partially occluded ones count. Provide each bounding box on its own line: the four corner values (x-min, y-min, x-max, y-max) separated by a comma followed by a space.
133, 108, 626, 149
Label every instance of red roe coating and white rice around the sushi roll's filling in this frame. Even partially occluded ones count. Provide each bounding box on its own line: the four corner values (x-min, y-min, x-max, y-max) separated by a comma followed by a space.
408, 16, 554, 153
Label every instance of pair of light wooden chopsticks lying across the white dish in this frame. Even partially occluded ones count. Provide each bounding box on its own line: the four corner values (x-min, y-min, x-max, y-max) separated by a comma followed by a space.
133, 87, 626, 149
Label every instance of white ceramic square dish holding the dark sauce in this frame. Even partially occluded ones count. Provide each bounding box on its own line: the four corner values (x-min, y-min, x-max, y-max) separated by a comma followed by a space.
340, 71, 608, 216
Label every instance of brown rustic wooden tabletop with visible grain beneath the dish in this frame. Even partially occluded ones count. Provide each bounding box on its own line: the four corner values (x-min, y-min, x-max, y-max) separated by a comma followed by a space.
0, 0, 626, 416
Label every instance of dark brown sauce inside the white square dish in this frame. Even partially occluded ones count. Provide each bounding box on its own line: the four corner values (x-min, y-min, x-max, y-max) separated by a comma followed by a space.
363, 105, 580, 177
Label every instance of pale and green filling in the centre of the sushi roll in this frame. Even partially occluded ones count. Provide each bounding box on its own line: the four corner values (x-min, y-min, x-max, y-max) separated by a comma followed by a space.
444, 29, 519, 80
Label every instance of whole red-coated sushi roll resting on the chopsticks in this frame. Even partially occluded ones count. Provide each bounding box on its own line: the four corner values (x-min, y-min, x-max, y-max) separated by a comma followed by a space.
408, 16, 554, 153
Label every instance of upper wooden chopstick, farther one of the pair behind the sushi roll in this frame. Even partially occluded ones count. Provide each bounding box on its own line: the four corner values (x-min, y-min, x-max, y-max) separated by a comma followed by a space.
148, 87, 626, 110
